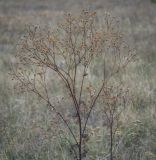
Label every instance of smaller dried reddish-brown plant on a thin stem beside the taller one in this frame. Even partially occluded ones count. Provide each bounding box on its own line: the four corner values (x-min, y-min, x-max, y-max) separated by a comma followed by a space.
100, 83, 129, 160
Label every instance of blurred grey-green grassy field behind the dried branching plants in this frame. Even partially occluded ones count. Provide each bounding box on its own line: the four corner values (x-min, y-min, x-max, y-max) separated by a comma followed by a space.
0, 0, 156, 160
